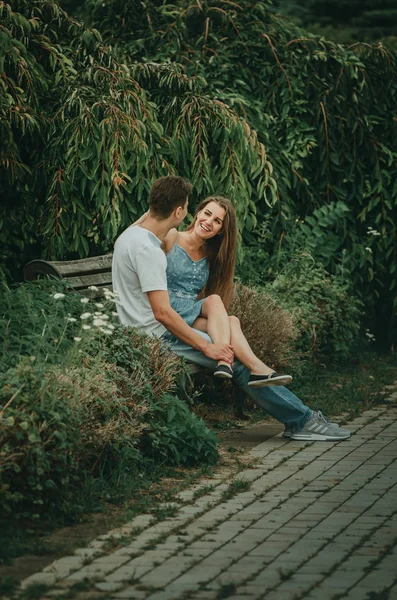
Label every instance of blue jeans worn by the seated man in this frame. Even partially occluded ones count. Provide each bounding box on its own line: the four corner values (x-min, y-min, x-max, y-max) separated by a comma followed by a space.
162, 329, 312, 432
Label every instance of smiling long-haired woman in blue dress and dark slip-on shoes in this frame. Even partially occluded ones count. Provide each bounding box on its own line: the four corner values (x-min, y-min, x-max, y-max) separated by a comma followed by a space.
160, 196, 292, 387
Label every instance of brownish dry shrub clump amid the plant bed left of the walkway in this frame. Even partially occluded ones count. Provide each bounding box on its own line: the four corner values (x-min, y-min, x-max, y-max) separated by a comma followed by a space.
52, 327, 187, 466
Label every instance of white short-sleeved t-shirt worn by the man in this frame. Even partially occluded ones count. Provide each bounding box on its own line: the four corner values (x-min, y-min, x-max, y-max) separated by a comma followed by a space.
112, 226, 167, 337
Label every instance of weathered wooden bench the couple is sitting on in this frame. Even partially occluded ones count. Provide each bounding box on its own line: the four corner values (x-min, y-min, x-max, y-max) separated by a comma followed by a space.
23, 254, 246, 419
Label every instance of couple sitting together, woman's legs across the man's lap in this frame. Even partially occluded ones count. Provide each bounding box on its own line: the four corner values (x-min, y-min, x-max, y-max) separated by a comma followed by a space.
112, 176, 350, 441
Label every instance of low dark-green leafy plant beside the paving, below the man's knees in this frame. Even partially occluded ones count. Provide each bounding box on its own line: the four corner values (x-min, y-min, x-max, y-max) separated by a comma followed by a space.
145, 394, 218, 465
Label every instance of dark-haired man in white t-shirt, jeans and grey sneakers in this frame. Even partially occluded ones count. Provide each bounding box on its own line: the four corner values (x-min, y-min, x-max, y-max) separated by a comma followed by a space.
112, 176, 350, 441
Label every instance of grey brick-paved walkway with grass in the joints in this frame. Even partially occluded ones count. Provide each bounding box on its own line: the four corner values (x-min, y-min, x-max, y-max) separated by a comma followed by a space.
17, 392, 397, 600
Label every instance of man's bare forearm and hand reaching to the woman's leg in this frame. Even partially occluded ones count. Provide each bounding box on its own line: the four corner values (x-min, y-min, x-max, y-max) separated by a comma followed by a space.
147, 290, 234, 363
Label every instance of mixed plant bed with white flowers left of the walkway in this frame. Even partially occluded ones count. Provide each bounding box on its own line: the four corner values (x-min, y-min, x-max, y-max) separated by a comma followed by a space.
0, 281, 217, 526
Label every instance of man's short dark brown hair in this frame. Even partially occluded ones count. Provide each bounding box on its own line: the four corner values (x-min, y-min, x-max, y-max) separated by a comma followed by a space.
149, 175, 192, 219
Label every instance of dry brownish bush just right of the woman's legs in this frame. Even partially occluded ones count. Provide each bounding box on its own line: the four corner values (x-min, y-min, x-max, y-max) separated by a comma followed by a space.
230, 284, 297, 369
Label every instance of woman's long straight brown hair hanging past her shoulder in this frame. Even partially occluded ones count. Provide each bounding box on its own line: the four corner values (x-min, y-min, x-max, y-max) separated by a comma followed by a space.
186, 196, 237, 309
